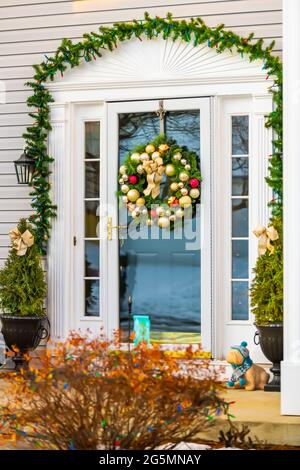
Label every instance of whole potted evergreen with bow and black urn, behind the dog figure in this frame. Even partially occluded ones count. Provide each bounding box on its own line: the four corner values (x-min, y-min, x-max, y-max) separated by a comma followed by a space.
250, 218, 283, 391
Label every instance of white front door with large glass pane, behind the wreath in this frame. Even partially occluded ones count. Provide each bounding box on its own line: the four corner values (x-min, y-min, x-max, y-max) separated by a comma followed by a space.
106, 98, 211, 351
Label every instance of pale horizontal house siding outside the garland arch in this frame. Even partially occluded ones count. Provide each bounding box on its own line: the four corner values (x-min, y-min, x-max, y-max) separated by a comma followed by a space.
0, 0, 282, 266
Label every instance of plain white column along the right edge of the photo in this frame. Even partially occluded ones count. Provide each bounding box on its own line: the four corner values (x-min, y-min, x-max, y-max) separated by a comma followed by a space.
281, 0, 300, 415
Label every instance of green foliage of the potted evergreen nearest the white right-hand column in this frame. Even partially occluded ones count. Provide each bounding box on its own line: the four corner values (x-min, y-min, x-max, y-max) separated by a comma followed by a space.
250, 218, 283, 325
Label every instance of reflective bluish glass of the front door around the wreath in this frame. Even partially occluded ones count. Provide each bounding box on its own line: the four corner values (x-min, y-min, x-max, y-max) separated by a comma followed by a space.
118, 100, 210, 344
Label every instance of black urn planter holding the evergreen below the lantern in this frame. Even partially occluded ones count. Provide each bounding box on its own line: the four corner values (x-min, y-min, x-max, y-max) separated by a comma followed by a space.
0, 315, 50, 370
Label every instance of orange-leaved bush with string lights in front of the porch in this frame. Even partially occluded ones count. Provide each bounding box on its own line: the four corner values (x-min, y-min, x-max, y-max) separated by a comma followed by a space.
0, 334, 228, 450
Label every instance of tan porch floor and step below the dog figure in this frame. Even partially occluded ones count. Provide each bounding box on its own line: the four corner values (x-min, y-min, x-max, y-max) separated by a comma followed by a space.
199, 389, 300, 446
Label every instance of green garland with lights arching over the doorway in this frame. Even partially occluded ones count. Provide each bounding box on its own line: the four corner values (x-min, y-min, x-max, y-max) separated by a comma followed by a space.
23, 13, 282, 254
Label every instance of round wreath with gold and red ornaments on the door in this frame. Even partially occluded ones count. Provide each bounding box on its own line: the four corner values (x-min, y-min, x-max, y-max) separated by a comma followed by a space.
118, 135, 201, 228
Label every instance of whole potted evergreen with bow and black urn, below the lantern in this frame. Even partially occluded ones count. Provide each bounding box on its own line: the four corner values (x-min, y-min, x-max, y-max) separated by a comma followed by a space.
0, 219, 49, 369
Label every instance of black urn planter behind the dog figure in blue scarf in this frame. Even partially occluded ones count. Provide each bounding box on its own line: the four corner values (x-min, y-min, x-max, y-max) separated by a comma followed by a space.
254, 323, 283, 392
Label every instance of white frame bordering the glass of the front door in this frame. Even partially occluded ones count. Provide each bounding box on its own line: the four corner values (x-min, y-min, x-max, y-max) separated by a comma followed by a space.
106, 97, 213, 352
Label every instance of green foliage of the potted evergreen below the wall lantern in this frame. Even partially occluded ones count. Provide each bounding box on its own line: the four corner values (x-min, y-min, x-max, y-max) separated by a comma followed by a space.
0, 219, 47, 317
